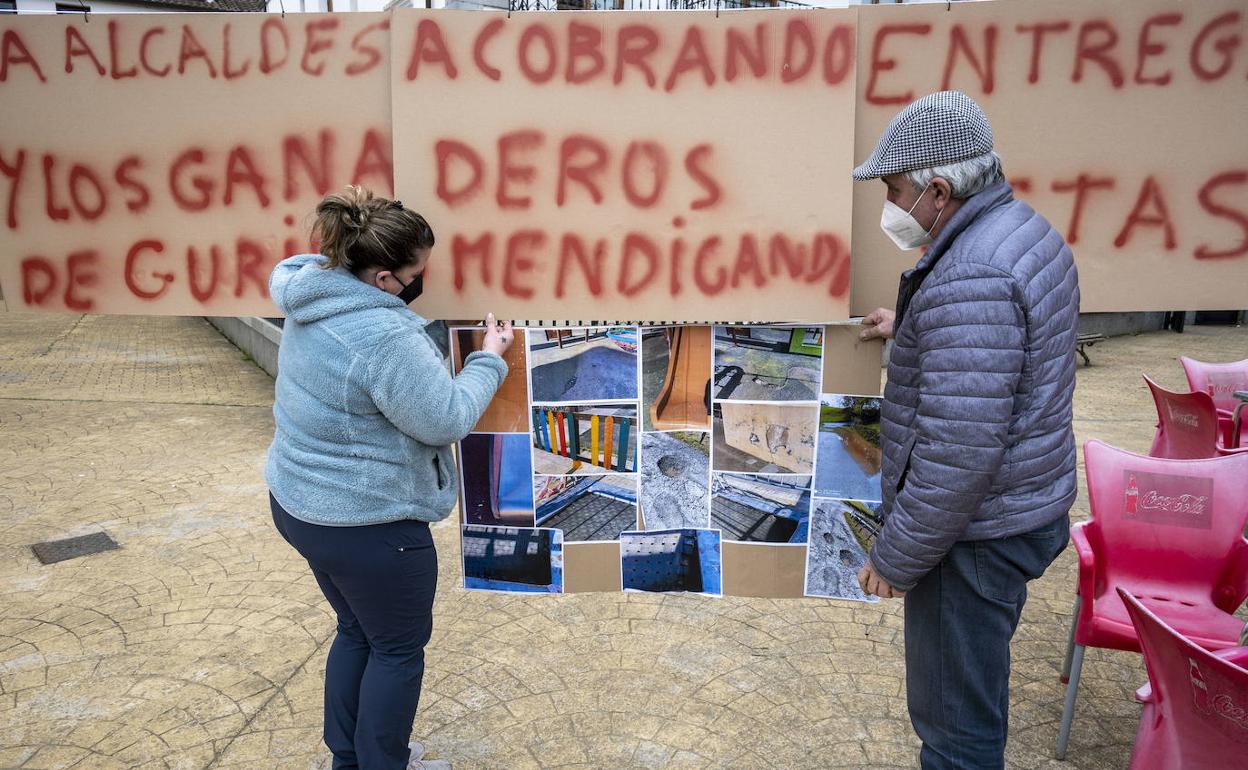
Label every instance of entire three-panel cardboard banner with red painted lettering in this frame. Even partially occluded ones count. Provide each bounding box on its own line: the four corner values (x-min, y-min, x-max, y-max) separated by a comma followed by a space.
0, 0, 1248, 322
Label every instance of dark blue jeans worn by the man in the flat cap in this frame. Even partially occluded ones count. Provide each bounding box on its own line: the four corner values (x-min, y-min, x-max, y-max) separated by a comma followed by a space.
905, 517, 1070, 770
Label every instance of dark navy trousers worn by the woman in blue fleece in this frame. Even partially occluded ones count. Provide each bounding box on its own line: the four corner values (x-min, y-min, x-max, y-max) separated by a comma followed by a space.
268, 495, 438, 770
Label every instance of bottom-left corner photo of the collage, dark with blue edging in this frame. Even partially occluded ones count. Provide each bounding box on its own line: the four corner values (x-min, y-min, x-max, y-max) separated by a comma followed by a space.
461, 524, 563, 594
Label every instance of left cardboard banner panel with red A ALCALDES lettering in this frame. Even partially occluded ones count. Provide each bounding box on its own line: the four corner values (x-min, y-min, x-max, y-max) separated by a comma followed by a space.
0, 14, 392, 316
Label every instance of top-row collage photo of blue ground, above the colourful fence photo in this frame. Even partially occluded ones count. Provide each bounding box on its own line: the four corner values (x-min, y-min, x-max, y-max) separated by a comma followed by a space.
528, 326, 638, 403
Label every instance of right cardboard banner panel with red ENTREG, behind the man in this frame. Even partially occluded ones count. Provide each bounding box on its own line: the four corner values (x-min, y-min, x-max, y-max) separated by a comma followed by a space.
852, 0, 1248, 314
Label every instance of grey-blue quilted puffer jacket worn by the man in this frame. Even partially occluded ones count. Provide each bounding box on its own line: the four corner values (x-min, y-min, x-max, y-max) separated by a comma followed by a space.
871, 182, 1080, 590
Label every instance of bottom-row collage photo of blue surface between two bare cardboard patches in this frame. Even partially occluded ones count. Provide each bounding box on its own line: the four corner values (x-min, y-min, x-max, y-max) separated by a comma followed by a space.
620, 529, 723, 595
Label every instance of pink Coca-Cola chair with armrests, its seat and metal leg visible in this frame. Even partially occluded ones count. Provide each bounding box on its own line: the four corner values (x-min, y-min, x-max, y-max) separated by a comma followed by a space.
1057, 441, 1248, 759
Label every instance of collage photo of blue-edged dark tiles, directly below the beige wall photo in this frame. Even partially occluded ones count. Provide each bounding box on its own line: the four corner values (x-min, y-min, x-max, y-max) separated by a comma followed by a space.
710, 473, 810, 544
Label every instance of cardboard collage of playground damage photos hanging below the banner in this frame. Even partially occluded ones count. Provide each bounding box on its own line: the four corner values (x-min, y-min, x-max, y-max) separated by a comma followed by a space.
451, 324, 881, 600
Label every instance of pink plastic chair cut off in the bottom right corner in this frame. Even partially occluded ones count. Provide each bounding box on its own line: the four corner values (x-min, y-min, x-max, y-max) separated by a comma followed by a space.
1118, 588, 1248, 770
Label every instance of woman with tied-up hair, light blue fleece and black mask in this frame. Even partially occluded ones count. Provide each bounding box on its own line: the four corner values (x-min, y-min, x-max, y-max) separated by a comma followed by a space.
265, 187, 513, 770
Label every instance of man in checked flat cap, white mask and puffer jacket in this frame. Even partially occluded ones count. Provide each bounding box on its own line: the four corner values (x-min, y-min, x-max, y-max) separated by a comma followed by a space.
854, 91, 1080, 770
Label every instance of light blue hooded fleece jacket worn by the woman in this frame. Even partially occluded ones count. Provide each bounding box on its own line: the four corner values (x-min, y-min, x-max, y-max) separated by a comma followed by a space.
265, 255, 507, 527
